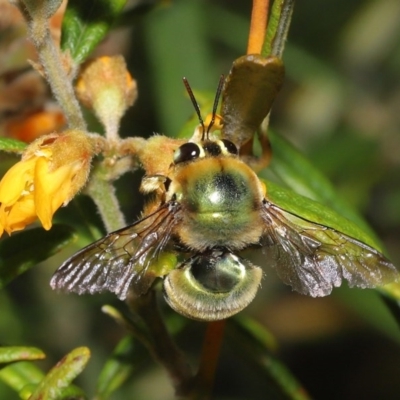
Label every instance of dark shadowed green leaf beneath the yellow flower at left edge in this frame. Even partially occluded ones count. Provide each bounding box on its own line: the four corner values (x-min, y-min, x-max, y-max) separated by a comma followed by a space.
0, 225, 74, 289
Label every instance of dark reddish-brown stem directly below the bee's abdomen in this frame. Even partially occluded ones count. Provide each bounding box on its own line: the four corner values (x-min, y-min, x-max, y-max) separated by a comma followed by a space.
196, 319, 226, 399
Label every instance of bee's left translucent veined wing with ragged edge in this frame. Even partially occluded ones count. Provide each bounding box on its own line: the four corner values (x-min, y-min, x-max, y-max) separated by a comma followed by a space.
50, 204, 180, 300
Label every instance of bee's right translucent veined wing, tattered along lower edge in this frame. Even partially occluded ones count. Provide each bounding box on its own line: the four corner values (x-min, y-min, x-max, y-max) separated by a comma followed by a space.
263, 202, 400, 297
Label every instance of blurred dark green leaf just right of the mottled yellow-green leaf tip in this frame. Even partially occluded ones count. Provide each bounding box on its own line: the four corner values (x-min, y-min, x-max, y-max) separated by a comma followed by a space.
96, 336, 135, 400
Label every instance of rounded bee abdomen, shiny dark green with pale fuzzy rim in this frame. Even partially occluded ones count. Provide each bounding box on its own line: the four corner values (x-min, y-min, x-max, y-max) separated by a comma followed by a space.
164, 252, 262, 321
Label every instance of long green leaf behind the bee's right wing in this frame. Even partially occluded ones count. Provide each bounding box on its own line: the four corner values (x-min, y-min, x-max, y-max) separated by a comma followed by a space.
267, 130, 400, 301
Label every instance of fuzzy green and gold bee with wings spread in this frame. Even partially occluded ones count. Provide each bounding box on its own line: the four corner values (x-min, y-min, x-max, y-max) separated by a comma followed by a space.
51, 56, 399, 321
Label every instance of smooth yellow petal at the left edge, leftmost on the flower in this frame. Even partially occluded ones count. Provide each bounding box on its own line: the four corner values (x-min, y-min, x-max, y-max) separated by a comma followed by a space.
0, 158, 36, 206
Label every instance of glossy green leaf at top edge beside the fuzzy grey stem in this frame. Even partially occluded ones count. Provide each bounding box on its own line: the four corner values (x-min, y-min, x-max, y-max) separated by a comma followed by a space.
61, 0, 126, 64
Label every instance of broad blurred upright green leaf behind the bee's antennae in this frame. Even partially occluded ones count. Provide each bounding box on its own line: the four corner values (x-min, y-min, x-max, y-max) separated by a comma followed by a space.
143, 1, 217, 136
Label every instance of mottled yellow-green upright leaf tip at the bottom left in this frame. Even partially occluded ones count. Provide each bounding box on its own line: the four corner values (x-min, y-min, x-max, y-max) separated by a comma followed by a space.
30, 347, 90, 400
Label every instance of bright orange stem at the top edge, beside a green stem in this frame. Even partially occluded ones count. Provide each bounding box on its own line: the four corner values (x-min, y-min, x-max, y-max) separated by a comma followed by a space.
247, 0, 269, 54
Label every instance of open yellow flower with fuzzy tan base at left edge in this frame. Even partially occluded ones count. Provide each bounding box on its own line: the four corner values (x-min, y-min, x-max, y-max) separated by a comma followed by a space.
0, 131, 93, 236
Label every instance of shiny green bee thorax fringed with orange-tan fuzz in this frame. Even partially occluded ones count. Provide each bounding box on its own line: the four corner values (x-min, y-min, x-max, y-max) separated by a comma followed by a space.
172, 158, 263, 250
